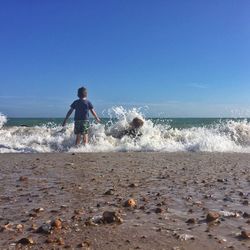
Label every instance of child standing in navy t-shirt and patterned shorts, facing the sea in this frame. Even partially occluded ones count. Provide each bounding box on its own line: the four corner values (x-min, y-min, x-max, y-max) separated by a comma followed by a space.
62, 87, 100, 145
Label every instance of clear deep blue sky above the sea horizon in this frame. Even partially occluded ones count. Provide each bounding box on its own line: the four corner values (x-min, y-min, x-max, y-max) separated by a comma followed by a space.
0, 0, 250, 117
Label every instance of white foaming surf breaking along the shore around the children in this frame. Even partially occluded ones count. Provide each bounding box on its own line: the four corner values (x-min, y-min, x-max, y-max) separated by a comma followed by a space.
0, 107, 250, 153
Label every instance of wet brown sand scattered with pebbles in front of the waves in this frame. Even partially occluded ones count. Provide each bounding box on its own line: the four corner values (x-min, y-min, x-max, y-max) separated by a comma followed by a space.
0, 153, 250, 250
